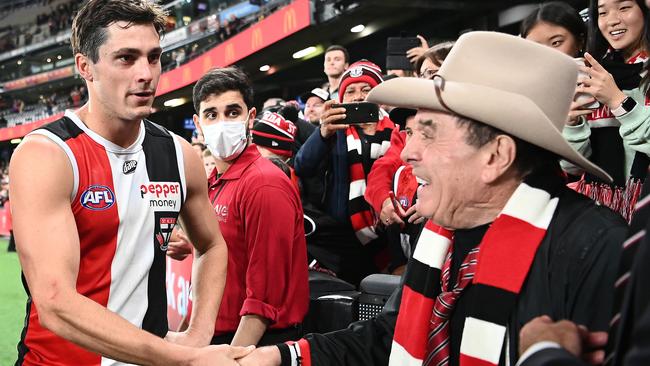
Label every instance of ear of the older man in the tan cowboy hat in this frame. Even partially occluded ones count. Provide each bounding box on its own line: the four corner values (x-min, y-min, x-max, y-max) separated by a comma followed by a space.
481, 135, 517, 184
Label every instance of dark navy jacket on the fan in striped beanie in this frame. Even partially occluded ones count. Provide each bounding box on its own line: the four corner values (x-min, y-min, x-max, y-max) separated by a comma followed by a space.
293, 128, 350, 223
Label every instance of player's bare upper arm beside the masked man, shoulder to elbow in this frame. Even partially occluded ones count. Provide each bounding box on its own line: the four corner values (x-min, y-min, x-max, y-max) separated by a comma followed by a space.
180, 135, 222, 253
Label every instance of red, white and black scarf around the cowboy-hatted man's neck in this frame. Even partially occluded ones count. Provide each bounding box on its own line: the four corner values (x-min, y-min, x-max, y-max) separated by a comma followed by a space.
389, 177, 563, 366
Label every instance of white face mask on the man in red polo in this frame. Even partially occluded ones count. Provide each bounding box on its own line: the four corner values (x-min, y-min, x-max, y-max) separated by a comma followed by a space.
203, 120, 248, 161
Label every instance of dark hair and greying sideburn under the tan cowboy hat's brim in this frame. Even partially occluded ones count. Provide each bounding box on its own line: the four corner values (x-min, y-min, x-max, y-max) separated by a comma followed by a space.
455, 115, 561, 177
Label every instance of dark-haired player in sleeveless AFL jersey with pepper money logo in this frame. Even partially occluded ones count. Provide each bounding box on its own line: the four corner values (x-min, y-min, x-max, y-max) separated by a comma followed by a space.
10, 0, 249, 366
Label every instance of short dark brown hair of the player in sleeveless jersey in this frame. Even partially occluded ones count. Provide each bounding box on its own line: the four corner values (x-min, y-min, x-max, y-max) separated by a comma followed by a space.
70, 0, 167, 63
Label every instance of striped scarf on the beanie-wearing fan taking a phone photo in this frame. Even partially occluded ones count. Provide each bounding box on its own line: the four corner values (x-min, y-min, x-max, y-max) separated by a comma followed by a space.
345, 113, 395, 245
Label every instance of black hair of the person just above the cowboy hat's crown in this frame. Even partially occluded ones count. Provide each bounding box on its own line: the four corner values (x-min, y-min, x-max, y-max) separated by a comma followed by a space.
521, 1, 587, 56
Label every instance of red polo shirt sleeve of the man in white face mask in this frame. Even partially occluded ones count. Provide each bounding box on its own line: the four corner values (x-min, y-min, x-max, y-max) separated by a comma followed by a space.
239, 183, 300, 323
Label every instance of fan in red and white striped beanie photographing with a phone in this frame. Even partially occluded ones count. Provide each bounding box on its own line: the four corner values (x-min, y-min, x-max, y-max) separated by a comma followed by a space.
294, 60, 395, 283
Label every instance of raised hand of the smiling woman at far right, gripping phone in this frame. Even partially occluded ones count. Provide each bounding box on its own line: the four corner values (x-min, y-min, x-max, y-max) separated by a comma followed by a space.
576, 53, 627, 109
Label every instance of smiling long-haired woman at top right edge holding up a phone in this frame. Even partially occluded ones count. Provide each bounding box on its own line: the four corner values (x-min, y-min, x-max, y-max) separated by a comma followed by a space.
562, 0, 650, 221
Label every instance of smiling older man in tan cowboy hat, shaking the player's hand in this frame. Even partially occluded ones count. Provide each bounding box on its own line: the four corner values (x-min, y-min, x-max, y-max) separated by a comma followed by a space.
239, 32, 626, 366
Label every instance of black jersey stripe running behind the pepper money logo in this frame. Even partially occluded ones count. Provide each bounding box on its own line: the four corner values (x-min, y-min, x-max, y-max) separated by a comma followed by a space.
142, 120, 185, 337
